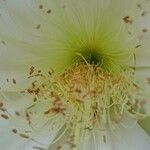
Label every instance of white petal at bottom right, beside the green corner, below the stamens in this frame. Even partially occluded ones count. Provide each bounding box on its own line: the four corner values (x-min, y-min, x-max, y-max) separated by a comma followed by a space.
78, 116, 150, 150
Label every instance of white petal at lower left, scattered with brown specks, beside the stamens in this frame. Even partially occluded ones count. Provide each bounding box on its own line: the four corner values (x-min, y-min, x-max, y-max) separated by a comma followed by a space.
0, 92, 64, 150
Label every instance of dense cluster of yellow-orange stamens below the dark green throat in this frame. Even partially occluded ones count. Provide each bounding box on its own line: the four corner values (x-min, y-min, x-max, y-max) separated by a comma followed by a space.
24, 64, 144, 129
